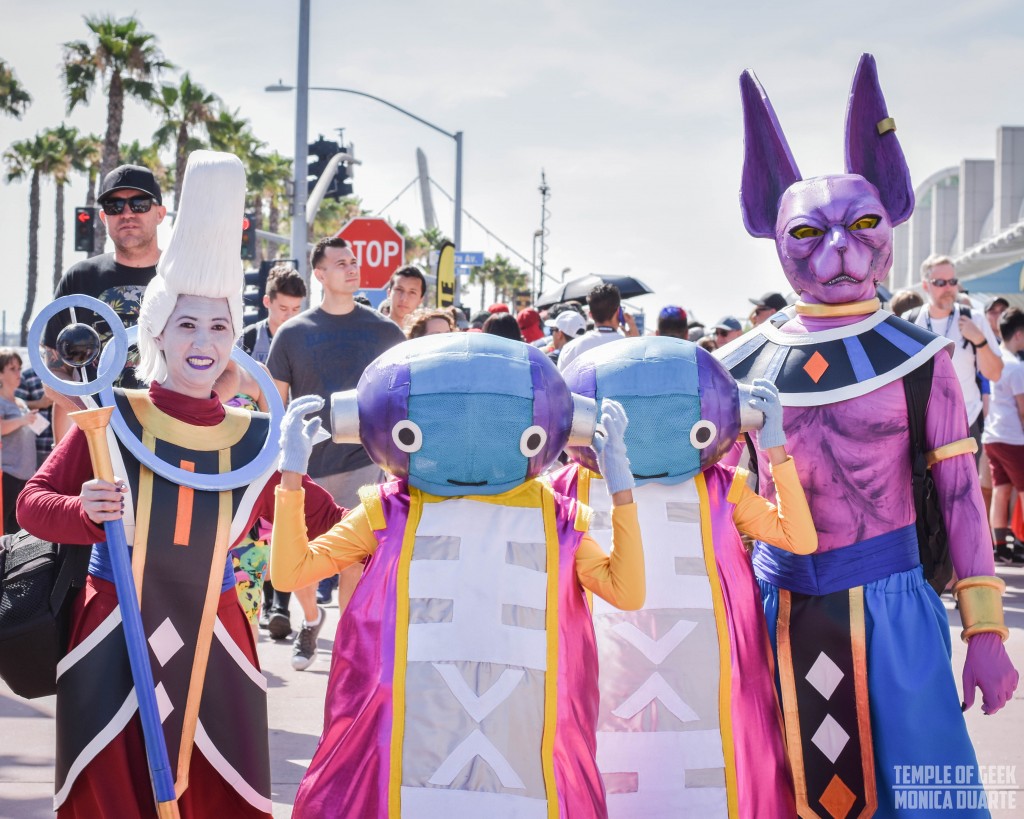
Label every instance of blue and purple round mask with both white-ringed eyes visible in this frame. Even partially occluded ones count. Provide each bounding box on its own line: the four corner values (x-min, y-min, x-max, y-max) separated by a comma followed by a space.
356, 333, 572, 497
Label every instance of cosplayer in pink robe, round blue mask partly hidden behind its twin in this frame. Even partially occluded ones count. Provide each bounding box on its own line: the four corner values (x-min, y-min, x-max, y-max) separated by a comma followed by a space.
552, 337, 816, 819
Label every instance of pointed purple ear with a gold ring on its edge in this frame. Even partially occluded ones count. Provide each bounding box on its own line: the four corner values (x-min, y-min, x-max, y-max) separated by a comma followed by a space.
846, 54, 913, 225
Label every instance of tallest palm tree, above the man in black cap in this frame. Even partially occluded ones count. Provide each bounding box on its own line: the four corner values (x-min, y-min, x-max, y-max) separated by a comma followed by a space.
63, 14, 174, 248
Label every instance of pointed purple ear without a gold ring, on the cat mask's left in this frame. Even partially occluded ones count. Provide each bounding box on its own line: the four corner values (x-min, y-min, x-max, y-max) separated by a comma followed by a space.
739, 70, 800, 239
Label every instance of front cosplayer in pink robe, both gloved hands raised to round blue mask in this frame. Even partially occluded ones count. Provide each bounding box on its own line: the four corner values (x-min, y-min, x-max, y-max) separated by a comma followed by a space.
271, 334, 644, 819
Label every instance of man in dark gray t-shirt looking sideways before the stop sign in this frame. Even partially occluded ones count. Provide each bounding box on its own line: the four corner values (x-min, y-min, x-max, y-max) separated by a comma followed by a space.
266, 238, 406, 671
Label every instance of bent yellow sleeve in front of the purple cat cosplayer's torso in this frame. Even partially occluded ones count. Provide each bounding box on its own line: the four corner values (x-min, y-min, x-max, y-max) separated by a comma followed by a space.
729, 457, 818, 555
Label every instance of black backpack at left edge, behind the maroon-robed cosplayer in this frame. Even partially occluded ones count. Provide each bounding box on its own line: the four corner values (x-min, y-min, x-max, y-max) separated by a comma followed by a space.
0, 530, 92, 699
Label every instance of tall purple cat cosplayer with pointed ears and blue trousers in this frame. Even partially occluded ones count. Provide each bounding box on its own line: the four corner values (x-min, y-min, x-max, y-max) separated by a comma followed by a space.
717, 54, 1018, 817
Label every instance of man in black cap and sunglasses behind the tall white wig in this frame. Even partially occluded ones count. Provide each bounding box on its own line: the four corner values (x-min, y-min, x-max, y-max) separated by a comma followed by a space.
43, 165, 167, 440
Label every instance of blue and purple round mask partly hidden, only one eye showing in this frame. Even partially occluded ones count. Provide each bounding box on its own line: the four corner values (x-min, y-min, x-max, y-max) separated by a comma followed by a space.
563, 336, 740, 484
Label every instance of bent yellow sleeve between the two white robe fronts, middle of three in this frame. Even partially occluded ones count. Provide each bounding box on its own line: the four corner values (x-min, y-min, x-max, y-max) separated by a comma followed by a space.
575, 504, 647, 611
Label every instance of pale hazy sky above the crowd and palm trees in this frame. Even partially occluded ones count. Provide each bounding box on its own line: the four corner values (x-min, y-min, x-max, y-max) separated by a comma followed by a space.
0, 0, 1024, 329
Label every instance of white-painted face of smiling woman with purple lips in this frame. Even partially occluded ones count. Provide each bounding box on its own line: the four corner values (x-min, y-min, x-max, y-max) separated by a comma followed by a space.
154, 296, 234, 398
